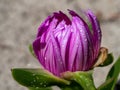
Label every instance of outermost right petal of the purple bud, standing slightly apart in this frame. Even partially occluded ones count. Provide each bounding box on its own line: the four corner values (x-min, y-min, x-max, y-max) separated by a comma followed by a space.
87, 10, 102, 63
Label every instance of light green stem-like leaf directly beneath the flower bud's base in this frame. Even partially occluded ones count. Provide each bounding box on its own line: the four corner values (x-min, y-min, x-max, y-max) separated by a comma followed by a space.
62, 71, 96, 90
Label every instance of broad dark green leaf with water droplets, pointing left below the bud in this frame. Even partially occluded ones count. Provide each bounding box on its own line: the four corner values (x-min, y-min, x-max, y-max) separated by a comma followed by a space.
12, 68, 70, 88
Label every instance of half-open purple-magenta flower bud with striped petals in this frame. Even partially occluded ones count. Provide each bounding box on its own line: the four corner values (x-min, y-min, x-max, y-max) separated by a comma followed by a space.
33, 10, 101, 76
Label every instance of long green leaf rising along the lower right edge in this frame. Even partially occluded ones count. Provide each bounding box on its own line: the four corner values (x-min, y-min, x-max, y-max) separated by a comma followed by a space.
98, 57, 120, 90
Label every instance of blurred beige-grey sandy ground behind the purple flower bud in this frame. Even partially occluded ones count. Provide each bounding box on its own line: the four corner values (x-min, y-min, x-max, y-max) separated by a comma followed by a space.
0, 0, 120, 90
